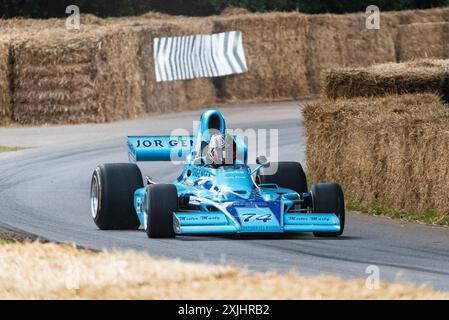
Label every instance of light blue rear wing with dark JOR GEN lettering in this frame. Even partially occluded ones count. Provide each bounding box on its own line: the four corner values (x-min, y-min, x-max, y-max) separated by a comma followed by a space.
128, 136, 248, 163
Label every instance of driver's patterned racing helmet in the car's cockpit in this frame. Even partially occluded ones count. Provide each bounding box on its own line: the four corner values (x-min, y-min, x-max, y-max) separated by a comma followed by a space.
208, 133, 237, 165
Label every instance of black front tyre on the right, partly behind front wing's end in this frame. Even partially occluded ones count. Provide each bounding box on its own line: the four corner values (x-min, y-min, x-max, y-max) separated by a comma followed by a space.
311, 183, 345, 237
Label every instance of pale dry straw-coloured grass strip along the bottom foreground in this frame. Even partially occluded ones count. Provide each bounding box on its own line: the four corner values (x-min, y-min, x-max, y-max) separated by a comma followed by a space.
0, 243, 449, 300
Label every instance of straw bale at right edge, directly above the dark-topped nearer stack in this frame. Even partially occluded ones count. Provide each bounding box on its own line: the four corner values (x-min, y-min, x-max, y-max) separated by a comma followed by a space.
398, 22, 449, 61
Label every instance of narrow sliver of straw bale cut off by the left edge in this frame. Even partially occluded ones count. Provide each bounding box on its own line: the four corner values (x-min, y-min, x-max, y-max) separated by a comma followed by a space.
0, 41, 11, 125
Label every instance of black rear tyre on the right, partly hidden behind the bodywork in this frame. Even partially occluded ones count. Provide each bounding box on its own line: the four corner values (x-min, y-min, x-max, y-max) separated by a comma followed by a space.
257, 162, 307, 195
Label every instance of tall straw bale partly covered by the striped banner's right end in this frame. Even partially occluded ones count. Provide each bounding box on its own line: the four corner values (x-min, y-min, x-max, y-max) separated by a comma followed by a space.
212, 13, 310, 102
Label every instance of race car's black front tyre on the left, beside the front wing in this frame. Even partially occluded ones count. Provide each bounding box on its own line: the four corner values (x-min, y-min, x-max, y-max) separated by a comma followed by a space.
144, 184, 178, 238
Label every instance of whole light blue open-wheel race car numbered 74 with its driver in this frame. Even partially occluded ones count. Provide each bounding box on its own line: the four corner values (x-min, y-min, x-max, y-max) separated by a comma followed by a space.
91, 110, 345, 238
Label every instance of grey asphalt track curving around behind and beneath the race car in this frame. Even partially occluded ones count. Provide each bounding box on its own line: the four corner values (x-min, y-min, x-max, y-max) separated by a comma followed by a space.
0, 103, 449, 289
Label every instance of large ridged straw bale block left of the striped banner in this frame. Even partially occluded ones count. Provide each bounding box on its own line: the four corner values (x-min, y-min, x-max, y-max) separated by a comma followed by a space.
12, 28, 143, 124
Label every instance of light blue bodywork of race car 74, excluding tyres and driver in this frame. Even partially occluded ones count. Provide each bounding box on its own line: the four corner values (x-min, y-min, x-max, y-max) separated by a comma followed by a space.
128, 110, 340, 234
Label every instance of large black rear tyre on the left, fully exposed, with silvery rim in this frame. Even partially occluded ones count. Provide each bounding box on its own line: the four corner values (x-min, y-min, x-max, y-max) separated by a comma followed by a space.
91, 163, 143, 230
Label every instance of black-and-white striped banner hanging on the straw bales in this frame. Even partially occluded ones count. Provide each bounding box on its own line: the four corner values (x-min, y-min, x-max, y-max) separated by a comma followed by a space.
153, 31, 248, 82
